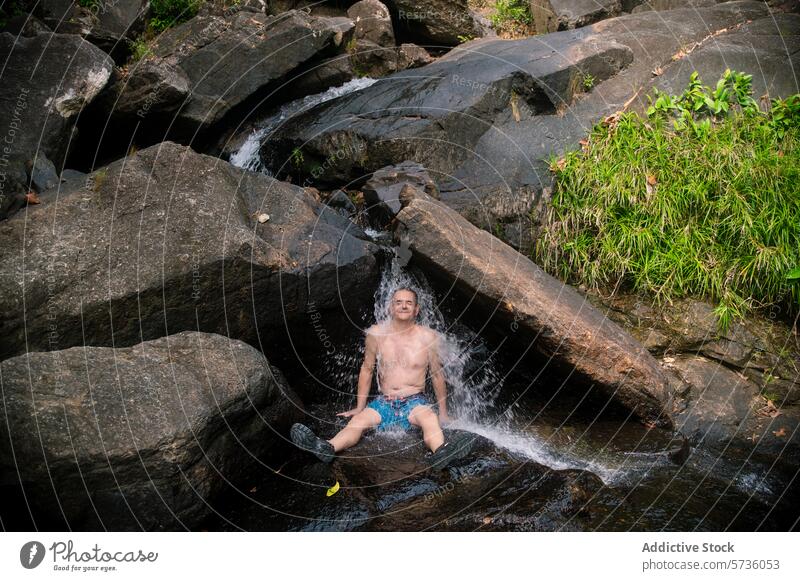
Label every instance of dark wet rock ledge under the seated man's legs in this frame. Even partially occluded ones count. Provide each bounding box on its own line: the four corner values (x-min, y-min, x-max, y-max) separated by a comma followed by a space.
233, 426, 602, 531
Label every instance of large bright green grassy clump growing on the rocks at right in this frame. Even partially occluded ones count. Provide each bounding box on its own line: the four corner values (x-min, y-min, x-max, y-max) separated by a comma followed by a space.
534, 71, 800, 330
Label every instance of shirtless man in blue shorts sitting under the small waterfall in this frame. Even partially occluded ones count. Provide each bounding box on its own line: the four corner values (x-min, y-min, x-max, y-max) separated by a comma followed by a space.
291, 288, 471, 468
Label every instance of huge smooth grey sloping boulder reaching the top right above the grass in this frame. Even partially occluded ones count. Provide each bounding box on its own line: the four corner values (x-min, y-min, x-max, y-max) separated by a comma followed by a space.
262, 1, 788, 249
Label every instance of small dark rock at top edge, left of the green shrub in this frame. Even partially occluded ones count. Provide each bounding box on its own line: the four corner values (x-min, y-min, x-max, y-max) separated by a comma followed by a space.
386, 0, 485, 46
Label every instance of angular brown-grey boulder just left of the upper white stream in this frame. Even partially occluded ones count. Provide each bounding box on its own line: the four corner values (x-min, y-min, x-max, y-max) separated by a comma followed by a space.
106, 11, 353, 140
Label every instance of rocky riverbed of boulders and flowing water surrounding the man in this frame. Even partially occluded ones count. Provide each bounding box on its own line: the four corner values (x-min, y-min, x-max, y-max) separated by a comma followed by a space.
0, 0, 800, 531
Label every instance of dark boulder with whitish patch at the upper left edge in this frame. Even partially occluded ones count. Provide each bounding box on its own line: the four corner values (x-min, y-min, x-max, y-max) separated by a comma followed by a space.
0, 33, 114, 219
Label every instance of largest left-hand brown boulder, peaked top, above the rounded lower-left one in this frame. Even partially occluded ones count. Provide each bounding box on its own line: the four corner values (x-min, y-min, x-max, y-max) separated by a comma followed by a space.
0, 142, 378, 358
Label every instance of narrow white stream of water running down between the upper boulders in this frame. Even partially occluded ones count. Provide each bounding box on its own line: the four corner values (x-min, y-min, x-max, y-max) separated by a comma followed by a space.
230, 77, 376, 174
